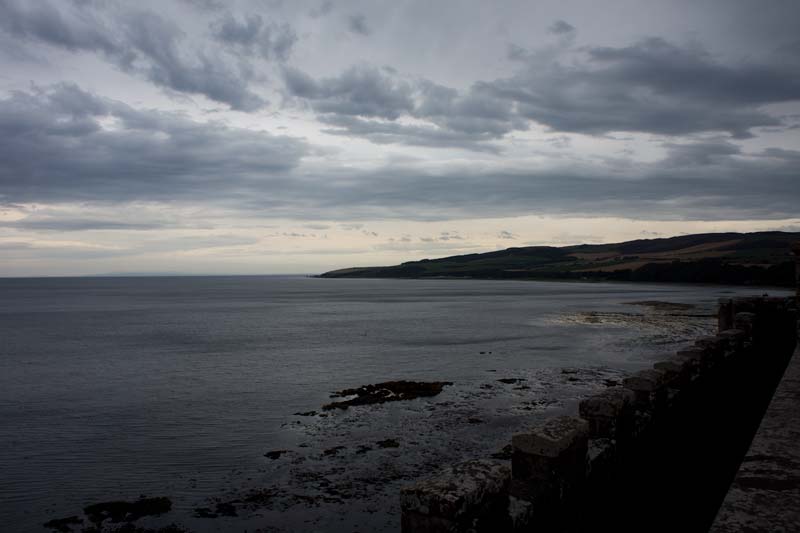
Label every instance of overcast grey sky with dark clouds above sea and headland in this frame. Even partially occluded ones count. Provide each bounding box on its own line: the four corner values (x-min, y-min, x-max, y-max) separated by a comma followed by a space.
0, 0, 800, 276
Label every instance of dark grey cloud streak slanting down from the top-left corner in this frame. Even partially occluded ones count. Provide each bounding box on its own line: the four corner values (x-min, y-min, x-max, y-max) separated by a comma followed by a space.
0, 0, 268, 111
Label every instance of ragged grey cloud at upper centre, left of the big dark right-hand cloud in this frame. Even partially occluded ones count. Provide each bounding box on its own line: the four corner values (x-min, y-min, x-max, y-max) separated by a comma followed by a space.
284, 66, 527, 152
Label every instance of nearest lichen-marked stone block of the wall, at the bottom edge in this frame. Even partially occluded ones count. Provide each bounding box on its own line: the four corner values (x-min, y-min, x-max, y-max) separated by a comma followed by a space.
400, 460, 511, 533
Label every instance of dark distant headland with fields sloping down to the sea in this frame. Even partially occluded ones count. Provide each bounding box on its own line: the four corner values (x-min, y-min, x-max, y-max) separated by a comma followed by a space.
320, 231, 800, 287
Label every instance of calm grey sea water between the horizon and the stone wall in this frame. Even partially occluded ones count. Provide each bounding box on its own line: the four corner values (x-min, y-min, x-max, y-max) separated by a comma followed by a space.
0, 277, 788, 531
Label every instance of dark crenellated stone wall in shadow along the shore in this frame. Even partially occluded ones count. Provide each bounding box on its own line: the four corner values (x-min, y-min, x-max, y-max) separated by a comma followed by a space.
401, 297, 797, 533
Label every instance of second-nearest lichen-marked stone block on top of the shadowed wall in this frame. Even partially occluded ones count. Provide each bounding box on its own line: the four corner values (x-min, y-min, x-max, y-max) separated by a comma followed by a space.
511, 416, 589, 504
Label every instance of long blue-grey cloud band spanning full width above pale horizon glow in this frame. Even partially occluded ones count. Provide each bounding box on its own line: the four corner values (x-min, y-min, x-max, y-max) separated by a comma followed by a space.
6, 85, 798, 221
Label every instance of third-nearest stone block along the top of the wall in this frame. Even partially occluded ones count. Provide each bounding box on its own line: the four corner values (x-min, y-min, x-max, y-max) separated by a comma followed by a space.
578, 387, 634, 439
